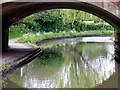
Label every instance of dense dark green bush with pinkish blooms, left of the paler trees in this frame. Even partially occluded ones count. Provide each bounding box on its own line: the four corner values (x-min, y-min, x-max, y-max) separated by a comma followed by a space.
17, 9, 64, 32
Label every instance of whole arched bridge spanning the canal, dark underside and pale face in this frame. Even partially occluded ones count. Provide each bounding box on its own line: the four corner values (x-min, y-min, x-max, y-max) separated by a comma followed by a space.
0, 0, 120, 62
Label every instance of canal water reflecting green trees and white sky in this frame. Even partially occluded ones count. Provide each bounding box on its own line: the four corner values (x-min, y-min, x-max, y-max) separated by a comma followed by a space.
2, 37, 115, 88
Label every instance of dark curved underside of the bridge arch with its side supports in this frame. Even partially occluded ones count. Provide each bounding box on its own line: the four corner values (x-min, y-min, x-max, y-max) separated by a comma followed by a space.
2, 2, 120, 61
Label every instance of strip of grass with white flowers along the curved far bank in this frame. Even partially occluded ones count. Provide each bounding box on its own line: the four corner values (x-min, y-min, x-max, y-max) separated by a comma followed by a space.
16, 30, 114, 44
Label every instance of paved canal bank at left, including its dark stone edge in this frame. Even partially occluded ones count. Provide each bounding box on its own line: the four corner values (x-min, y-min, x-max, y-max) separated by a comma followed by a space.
0, 38, 40, 79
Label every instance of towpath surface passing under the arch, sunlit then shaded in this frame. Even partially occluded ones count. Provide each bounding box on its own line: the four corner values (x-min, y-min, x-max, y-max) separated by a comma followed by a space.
0, 38, 39, 66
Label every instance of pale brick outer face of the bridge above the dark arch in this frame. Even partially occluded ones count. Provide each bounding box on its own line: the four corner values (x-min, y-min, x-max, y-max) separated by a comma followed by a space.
0, 0, 120, 17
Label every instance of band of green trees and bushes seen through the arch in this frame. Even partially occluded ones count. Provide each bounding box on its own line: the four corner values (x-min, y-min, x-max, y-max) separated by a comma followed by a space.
9, 9, 114, 39
